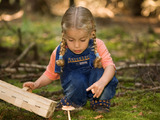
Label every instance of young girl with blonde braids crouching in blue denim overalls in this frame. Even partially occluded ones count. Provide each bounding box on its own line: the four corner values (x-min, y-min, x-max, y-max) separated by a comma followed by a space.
23, 7, 118, 112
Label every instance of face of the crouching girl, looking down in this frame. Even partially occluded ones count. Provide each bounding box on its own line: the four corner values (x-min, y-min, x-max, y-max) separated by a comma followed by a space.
64, 28, 91, 54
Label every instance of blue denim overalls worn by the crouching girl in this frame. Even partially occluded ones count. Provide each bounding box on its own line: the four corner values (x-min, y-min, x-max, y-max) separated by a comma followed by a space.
55, 39, 118, 106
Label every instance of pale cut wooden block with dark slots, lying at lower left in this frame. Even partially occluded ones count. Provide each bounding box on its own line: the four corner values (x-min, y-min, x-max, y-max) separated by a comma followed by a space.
0, 80, 57, 118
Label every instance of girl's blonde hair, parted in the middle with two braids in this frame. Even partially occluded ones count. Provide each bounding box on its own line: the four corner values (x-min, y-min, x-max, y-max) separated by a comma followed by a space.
56, 7, 102, 68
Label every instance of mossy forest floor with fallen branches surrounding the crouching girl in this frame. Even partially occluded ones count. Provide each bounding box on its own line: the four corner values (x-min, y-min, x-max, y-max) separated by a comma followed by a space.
0, 10, 160, 120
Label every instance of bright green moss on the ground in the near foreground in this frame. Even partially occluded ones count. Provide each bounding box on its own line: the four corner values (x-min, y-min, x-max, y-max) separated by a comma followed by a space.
0, 80, 160, 120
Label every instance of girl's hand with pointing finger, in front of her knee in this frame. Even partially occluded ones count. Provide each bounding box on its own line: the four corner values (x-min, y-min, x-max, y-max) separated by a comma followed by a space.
86, 80, 105, 98
